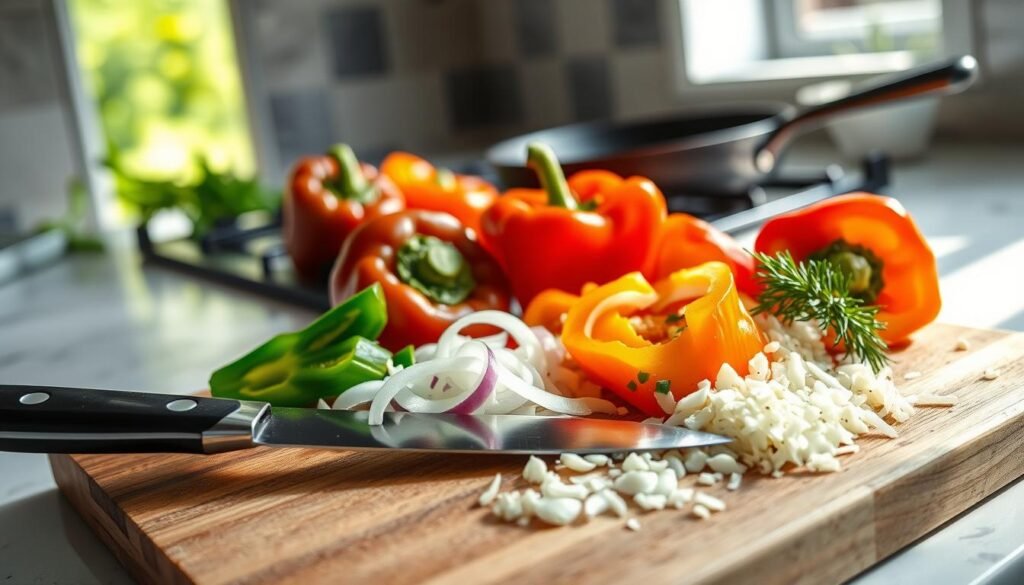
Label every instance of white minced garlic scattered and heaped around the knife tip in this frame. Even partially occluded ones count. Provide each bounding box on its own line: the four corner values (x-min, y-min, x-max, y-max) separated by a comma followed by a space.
479, 316, 954, 531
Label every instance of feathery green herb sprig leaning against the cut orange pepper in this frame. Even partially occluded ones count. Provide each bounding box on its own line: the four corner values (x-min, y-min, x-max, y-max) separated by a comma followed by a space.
754, 251, 889, 372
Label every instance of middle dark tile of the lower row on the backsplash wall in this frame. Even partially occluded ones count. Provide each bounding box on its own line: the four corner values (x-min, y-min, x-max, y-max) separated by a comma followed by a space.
444, 66, 523, 130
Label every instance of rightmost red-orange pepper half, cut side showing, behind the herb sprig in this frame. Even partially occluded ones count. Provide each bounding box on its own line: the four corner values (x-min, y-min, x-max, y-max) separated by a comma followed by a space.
754, 193, 942, 344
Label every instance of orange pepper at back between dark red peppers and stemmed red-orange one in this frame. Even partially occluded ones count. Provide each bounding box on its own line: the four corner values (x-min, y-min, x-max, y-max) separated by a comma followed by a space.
381, 153, 498, 234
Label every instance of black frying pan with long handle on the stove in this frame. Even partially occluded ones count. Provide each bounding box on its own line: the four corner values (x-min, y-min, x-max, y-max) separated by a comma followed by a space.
486, 55, 978, 194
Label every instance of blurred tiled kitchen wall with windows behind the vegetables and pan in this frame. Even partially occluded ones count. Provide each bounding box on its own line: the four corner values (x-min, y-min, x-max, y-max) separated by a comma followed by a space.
0, 0, 1024, 236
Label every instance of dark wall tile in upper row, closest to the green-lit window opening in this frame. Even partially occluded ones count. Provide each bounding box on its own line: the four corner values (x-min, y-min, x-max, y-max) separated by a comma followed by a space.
327, 6, 388, 79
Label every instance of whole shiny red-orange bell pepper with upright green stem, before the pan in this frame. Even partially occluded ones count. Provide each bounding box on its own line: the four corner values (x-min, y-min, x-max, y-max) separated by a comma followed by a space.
481, 144, 666, 306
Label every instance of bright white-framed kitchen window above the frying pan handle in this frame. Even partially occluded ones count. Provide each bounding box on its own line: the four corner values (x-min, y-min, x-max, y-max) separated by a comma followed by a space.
677, 0, 970, 89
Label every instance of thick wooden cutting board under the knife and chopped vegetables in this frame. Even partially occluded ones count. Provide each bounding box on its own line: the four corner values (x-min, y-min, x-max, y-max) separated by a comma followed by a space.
50, 325, 1024, 585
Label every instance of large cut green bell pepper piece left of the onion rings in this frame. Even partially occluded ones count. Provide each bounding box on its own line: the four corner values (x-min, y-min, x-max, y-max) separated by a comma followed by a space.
210, 284, 391, 407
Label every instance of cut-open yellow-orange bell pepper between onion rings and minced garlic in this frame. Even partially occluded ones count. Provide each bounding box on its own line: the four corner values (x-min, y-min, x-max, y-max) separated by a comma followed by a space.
561, 262, 765, 416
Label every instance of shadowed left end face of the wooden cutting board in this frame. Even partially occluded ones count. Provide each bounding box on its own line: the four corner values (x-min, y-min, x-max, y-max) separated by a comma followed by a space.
48, 454, 195, 585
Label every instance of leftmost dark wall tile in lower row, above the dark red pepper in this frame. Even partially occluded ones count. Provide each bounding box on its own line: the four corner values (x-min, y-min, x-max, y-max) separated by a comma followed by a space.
270, 90, 332, 164
